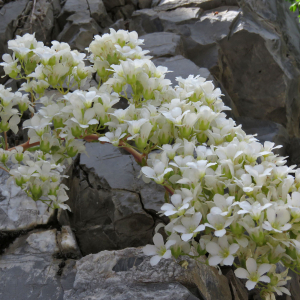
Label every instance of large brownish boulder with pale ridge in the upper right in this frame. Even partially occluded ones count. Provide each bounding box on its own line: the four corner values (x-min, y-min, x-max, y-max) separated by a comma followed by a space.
219, 0, 300, 136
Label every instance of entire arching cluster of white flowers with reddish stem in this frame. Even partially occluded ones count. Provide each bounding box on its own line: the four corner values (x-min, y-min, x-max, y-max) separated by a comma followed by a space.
0, 29, 300, 299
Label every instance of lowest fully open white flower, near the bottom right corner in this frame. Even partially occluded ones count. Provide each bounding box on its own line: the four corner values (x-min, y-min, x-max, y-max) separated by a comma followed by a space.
234, 257, 272, 290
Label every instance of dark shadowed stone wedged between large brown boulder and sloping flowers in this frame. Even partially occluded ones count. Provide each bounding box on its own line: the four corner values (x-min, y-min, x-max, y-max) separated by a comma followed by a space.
237, 117, 289, 155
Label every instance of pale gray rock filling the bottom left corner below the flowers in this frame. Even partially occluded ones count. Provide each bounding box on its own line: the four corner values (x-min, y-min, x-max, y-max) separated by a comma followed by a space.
0, 229, 75, 300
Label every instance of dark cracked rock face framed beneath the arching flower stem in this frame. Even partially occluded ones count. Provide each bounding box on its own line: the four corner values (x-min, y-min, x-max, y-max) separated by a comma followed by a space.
60, 143, 164, 255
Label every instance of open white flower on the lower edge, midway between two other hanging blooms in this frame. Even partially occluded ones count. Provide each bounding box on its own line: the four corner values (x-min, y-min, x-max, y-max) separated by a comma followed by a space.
206, 235, 239, 266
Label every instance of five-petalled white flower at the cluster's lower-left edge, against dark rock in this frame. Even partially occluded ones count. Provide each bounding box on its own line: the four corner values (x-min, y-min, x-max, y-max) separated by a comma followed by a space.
143, 233, 176, 266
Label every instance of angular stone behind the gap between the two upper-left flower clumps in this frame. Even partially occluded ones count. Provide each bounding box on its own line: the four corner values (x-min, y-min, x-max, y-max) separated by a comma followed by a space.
57, 12, 101, 51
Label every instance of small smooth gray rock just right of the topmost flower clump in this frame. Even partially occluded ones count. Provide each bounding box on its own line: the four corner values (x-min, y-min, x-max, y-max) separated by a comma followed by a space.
140, 32, 183, 57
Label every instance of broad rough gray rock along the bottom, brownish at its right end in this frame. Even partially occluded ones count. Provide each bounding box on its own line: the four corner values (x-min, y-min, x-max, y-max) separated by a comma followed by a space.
64, 248, 232, 300
